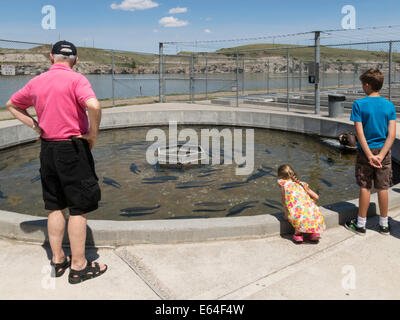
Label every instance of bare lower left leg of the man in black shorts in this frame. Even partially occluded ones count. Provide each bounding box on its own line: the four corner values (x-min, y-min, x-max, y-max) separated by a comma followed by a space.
47, 210, 65, 263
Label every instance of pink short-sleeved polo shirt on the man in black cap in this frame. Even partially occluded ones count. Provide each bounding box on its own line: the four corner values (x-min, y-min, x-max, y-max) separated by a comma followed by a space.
11, 64, 96, 141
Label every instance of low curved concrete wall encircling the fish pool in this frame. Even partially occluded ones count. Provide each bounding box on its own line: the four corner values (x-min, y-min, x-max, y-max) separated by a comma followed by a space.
0, 104, 400, 246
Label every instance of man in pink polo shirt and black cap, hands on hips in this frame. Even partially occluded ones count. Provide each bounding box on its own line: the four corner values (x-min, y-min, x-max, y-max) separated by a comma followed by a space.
6, 41, 107, 284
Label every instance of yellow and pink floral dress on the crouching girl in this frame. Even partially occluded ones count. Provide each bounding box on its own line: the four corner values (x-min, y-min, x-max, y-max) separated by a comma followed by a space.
278, 179, 326, 233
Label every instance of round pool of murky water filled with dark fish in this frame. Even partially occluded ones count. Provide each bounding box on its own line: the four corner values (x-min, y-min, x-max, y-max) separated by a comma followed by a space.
0, 126, 358, 221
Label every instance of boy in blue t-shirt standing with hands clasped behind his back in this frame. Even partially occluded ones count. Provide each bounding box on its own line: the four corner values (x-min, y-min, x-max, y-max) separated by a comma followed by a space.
345, 69, 396, 235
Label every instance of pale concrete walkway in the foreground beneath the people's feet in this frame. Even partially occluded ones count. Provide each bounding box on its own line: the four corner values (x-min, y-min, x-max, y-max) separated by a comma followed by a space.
0, 209, 400, 300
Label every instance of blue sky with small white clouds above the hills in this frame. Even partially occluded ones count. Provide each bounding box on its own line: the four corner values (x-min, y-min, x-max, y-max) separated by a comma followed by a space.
0, 0, 400, 53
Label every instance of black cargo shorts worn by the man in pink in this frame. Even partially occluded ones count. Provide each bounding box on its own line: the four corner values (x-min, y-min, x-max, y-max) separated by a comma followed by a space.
40, 138, 101, 215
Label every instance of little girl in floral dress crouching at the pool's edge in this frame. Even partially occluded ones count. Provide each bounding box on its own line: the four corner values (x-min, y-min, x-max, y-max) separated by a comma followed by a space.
277, 164, 326, 243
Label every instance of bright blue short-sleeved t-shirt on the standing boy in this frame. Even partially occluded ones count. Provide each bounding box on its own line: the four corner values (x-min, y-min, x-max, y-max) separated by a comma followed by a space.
350, 97, 396, 149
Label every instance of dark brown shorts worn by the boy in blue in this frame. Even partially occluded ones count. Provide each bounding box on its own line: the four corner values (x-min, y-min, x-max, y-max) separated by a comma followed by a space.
355, 148, 392, 190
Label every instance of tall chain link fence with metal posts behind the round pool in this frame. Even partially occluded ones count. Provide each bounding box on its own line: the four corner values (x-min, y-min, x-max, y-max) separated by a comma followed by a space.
0, 39, 400, 110
